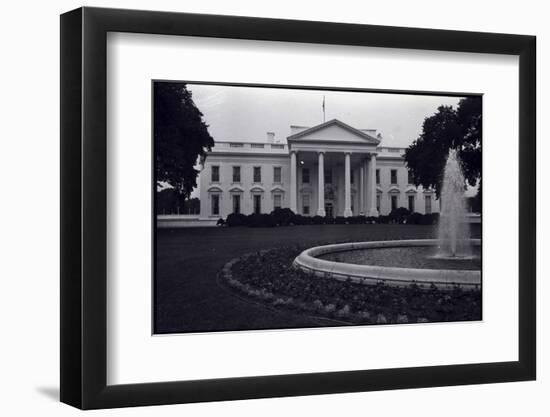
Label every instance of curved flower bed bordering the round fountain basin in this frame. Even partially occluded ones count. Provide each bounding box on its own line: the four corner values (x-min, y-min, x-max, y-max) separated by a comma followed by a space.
222, 247, 481, 324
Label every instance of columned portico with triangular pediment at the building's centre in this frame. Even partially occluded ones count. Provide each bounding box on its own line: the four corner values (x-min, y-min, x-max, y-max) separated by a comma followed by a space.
287, 120, 380, 217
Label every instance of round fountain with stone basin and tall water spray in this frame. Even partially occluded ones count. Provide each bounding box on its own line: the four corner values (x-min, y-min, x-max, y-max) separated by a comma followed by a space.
294, 150, 481, 289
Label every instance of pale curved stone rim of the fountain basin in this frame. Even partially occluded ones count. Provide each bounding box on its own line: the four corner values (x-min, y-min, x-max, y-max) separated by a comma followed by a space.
293, 239, 481, 289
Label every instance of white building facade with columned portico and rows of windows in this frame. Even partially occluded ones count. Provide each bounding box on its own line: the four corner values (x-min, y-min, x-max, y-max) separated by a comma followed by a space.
199, 119, 439, 220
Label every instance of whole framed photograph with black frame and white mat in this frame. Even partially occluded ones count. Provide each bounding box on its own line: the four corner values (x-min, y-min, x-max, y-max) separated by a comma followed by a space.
60, 8, 536, 409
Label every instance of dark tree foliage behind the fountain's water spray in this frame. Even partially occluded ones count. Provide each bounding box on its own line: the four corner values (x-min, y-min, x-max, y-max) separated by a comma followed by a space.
405, 97, 481, 200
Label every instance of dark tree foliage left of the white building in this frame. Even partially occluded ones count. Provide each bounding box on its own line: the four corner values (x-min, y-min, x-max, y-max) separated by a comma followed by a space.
154, 82, 214, 198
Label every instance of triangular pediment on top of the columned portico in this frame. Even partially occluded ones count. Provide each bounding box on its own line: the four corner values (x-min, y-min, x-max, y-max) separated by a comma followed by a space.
288, 119, 380, 145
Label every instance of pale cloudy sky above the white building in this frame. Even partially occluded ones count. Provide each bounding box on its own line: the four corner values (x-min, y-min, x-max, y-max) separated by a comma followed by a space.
187, 84, 460, 147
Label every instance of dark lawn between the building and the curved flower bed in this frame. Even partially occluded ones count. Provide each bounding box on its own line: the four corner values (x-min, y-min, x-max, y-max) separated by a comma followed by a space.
155, 224, 479, 333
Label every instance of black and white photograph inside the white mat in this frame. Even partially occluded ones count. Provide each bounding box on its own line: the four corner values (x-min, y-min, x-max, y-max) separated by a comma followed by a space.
151, 80, 483, 334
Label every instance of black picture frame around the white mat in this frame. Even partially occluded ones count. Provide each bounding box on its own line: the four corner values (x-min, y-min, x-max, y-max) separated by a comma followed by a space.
60, 7, 536, 409
